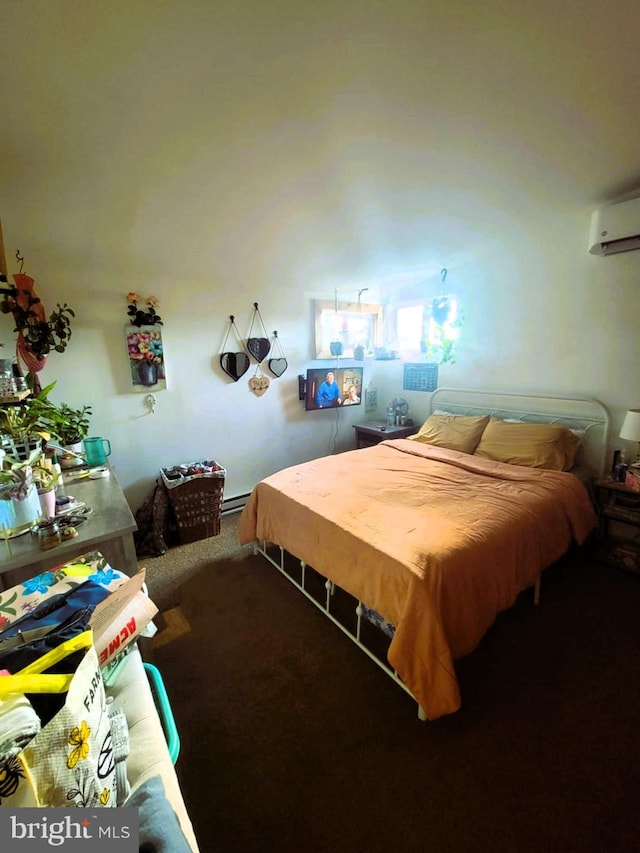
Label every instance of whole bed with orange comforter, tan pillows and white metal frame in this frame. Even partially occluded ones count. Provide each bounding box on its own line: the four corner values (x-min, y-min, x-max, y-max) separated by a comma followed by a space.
238, 389, 610, 720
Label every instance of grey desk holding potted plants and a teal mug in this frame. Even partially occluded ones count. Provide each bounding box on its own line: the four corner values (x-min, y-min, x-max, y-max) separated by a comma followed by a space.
0, 468, 138, 589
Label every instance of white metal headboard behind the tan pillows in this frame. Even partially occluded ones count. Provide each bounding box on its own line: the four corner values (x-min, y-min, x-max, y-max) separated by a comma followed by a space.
429, 388, 611, 477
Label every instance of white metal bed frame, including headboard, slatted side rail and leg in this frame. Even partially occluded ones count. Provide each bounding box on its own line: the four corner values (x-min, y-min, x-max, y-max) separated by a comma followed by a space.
254, 388, 611, 721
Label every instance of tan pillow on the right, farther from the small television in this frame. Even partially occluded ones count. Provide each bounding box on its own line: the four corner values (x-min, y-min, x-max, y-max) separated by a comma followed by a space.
475, 418, 580, 471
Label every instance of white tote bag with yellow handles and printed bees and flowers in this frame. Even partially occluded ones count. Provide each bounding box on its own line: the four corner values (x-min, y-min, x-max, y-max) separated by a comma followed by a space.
0, 630, 116, 808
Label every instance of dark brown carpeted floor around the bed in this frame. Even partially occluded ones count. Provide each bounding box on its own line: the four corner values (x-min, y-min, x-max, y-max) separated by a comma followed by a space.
140, 516, 640, 853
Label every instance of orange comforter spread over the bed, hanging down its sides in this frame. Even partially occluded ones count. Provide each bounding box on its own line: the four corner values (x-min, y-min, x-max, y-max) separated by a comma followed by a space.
239, 439, 595, 719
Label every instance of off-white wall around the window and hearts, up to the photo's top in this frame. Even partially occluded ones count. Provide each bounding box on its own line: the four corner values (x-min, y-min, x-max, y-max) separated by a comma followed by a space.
0, 0, 640, 507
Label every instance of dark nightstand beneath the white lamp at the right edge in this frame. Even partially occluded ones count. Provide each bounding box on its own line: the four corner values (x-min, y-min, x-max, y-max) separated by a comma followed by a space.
595, 479, 640, 574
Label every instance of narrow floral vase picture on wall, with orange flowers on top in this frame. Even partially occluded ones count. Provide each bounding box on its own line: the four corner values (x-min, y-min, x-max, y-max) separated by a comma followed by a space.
125, 292, 167, 391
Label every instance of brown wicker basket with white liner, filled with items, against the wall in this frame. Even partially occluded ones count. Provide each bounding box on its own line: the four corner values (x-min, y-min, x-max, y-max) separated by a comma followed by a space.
160, 463, 226, 545
